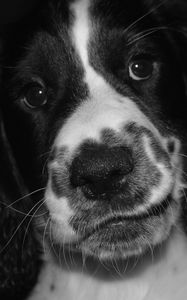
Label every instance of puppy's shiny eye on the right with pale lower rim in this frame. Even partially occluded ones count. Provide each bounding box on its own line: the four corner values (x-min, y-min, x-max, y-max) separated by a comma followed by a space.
129, 59, 154, 81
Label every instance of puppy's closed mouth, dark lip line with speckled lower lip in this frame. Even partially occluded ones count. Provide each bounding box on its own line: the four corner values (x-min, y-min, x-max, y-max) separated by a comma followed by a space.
66, 196, 176, 258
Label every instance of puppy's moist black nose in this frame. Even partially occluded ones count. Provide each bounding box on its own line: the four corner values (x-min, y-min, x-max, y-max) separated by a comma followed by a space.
70, 145, 133, 198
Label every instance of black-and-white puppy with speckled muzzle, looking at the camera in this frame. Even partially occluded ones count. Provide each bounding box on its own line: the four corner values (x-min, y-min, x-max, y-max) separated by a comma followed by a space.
1, 0, 187, 300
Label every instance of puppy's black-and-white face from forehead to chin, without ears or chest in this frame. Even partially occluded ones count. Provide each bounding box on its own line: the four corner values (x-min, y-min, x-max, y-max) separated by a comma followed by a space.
1, 0, 185, 259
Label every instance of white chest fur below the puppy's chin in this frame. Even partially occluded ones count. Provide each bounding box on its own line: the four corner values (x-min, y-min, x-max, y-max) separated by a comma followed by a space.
29, 227, 187, 300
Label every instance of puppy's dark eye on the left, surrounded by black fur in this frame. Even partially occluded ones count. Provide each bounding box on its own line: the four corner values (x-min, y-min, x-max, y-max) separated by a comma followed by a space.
21, 83, 47, 108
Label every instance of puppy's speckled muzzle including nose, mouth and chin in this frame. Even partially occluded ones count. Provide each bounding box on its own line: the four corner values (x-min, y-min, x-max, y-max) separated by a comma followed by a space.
46, 122, 182, 257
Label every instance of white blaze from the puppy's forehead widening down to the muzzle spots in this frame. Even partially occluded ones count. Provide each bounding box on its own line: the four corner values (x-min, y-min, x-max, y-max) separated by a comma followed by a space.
49, 0, 164, 152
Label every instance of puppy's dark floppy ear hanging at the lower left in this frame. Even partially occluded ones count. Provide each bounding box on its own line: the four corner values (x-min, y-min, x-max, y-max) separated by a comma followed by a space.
0, 110, 40, 300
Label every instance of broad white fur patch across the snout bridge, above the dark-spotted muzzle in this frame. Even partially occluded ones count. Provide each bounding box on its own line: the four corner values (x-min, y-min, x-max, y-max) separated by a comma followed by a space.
54, 94, 159, 153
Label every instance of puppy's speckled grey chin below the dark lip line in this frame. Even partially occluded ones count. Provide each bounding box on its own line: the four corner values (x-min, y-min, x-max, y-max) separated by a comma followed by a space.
75, 220, 172, 260
